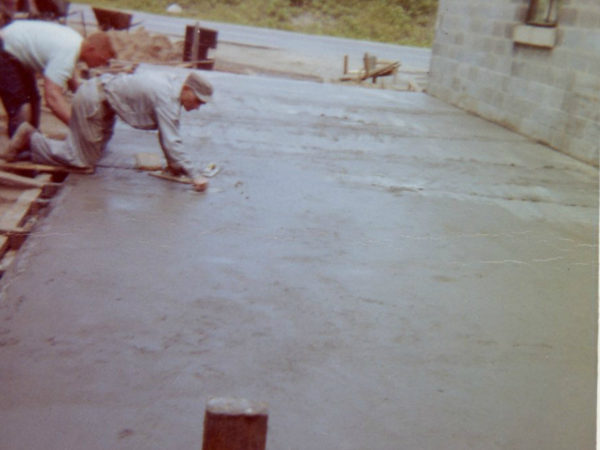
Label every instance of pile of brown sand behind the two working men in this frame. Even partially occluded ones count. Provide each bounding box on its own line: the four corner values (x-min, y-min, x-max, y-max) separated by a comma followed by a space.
107, 27, 184, 64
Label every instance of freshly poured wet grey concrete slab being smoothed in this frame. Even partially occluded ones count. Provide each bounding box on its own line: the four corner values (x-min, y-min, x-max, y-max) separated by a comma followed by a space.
0, 67, 598, 450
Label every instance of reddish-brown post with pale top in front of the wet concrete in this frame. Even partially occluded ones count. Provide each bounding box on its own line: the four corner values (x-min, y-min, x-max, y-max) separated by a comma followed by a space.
202, 398, 268, 450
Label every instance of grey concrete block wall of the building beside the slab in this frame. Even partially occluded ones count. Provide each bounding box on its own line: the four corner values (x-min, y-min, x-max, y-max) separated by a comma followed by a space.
427, 0, 600, 166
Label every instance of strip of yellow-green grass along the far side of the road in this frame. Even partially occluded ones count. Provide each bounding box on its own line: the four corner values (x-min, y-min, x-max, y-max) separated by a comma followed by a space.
77, 0, 437, 47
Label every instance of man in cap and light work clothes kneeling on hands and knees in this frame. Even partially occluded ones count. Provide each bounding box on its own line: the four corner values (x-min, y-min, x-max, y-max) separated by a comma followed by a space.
0, 71, 213, 191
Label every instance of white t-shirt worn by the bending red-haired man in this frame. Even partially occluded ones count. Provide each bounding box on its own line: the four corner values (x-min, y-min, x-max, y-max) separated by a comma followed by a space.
1, 20, 83, 87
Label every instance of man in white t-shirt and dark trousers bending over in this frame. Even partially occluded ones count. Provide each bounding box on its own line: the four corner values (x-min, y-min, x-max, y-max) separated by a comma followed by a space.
0, 20, 116, 136
